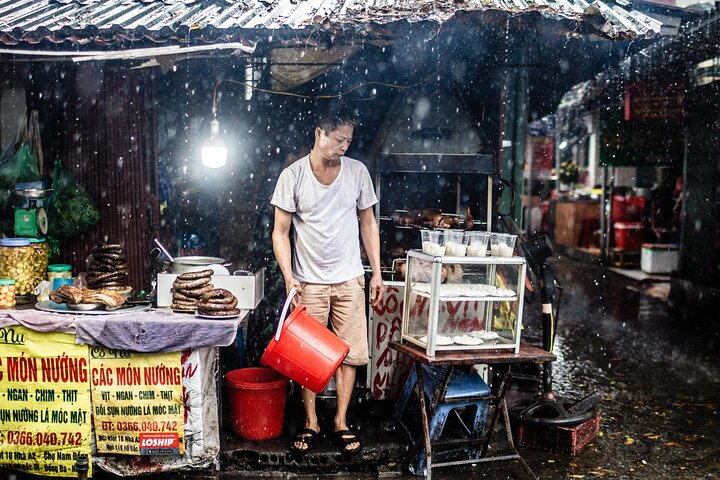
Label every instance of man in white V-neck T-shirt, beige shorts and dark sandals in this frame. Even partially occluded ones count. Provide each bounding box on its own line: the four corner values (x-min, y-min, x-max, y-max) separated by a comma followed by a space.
270, 110, 385, 454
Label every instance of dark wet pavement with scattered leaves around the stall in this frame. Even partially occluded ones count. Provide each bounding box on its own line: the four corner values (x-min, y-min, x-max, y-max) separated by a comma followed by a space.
7, 258, 720, 480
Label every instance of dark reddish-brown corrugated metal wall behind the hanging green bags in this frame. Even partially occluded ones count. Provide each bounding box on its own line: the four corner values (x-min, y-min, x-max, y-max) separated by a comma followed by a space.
38, 66, 159, 291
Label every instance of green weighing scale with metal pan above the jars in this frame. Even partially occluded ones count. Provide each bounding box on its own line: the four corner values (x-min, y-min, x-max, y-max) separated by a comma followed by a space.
15, 182, 52, 238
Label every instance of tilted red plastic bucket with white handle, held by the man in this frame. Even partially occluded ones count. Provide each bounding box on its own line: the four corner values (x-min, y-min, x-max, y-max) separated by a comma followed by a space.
260, 289, 350, 393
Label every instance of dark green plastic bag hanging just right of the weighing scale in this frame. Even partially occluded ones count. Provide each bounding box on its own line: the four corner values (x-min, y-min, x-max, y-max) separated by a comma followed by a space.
48, 160, 100, 238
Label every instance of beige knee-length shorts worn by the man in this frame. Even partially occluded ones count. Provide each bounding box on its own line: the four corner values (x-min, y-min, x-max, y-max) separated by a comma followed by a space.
300, 276, 369, 365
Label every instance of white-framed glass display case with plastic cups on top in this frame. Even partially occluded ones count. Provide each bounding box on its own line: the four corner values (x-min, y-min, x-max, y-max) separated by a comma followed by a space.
402, 250, 526, 356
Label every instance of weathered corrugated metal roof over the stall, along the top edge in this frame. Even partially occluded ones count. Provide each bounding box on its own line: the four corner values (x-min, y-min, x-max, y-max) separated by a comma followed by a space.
0, 0, 661, 45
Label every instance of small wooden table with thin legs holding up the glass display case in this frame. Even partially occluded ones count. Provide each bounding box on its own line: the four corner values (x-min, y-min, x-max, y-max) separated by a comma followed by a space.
390, 341, 556, 480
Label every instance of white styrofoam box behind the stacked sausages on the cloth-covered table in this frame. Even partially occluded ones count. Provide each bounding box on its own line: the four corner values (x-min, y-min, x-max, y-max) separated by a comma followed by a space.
157, 268, 265, 310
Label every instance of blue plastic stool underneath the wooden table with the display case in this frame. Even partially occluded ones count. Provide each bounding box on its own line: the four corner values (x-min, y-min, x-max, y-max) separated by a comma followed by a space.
395, 364, 491, 473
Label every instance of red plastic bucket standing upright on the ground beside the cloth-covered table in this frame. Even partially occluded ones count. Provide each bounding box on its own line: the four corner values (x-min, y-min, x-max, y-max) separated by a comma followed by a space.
225, 367, 290, 440
